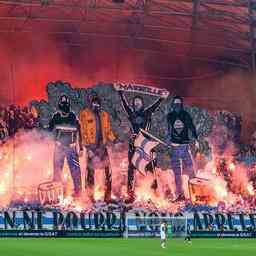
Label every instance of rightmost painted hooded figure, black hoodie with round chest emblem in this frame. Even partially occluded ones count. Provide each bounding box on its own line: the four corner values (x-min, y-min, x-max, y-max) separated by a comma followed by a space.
167, 96, 198, 201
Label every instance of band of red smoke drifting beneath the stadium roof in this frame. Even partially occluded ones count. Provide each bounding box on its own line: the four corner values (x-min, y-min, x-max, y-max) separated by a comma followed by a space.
0, 17, 256, 142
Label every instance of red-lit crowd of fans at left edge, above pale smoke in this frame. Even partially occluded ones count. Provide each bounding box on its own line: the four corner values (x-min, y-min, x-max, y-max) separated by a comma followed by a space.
0, 105, 38, 142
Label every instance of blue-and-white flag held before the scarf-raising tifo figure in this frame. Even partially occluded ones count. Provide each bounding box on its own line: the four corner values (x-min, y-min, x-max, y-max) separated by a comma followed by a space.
132, 131, 160, 172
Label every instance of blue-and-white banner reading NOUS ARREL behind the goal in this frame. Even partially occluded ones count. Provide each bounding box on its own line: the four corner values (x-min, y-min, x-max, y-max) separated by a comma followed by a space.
126, 210, 256, 237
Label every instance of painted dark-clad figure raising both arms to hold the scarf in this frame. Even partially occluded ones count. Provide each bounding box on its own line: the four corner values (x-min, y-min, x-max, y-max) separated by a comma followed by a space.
119, 91, 163, 202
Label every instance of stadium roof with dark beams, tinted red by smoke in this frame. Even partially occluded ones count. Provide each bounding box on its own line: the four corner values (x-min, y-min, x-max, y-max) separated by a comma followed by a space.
0, 0, 255, 78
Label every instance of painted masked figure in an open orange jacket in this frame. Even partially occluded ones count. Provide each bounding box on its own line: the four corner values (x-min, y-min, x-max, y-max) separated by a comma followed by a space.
79, 95, 117, 202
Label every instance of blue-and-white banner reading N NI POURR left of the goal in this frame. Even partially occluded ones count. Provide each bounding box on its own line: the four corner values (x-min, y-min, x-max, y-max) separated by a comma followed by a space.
0, 211, 124, 232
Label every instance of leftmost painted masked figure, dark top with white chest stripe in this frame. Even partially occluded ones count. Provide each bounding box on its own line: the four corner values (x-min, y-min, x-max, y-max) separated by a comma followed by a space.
49, 95, 82, 197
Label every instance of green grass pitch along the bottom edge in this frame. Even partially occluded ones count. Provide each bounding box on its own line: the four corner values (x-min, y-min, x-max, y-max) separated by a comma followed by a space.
0, 238, 256, 256
